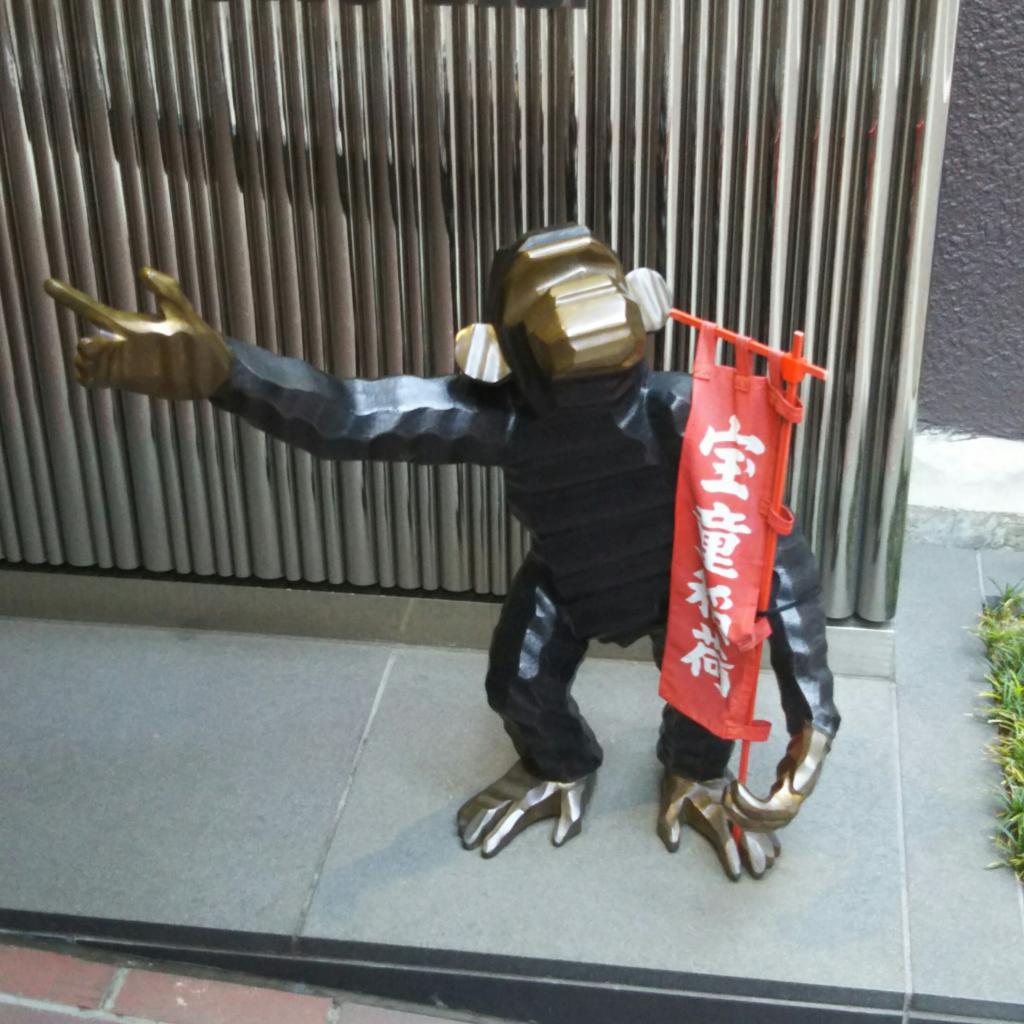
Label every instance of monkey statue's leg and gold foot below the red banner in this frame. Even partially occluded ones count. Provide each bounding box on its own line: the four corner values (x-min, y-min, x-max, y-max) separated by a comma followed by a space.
651, 630, 780, 881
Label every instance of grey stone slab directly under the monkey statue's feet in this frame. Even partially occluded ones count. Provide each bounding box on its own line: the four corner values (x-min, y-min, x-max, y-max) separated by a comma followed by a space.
303, 649, 904, 1007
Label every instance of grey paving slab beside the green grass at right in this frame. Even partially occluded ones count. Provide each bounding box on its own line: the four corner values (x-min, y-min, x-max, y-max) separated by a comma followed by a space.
896, 545, 1024, 1020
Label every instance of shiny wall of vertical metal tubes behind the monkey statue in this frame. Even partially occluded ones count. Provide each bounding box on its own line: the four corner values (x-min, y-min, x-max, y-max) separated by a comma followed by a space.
0, 0, 957, 621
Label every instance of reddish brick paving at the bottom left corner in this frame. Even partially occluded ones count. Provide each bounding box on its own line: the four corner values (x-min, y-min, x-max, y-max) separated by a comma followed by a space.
0, 945, 483, 1024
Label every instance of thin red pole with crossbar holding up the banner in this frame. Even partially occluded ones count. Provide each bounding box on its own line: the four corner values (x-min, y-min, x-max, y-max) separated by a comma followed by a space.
671, 309, 828, 798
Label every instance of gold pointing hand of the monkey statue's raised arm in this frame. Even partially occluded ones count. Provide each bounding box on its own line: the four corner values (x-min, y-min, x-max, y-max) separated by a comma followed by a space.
43, 267, 233, 398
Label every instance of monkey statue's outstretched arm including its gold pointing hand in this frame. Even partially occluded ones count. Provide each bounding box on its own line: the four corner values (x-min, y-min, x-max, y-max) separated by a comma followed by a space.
45, 268, 514, 465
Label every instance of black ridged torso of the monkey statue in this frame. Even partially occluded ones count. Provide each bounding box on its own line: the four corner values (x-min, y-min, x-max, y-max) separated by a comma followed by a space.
505, 367, 690, 643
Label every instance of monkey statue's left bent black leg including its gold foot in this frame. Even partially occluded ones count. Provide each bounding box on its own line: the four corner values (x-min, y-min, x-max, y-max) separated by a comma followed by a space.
458, 558, 602, 856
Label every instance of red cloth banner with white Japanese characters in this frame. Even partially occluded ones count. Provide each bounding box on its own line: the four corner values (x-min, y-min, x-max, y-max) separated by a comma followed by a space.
660, 324, 786, 740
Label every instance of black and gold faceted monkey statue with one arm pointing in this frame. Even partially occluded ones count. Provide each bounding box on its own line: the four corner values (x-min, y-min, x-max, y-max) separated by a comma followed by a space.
45, 225, 840, 879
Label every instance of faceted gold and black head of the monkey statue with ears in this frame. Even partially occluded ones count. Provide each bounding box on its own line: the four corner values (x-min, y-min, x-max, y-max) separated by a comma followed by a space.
456, 224, 671, 400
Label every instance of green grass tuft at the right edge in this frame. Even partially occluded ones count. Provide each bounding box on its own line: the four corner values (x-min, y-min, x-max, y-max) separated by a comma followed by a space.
978, 586, 1024, 879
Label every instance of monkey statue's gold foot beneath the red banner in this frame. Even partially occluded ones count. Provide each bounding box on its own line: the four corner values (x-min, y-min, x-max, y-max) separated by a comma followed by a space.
657, 771, 782, 882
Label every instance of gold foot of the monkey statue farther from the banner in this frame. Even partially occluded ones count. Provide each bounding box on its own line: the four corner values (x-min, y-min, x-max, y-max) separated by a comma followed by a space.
458, 761, 597, 857
